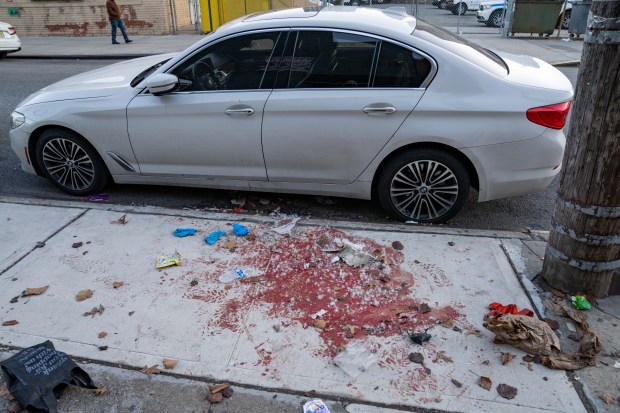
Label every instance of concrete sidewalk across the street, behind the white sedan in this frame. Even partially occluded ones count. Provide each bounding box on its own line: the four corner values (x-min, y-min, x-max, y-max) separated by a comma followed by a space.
9, 28, 583, 65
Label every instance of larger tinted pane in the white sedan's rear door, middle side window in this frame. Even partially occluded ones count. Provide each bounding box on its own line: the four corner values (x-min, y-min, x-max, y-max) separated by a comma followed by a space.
277, 31, 379, 88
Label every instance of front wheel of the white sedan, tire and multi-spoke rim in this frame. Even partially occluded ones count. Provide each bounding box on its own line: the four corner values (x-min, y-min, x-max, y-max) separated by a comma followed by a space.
35, 129, 109, 195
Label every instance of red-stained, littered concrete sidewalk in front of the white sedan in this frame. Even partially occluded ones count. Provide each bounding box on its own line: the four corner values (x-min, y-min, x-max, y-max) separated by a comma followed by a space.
0, 198, 620, 413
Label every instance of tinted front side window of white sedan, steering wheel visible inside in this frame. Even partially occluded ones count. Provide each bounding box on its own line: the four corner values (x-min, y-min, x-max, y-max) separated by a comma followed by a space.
172, 31, 280, 92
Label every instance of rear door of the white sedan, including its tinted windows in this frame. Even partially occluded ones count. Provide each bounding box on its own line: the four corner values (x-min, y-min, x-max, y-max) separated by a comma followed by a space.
263, 30, 432, 184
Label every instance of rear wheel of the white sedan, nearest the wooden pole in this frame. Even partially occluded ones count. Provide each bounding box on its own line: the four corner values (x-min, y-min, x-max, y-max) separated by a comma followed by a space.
377, 148, 470, 224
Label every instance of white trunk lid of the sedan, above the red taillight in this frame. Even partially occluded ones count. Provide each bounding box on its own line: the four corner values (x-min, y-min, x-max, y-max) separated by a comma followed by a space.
494, 51, 573, 101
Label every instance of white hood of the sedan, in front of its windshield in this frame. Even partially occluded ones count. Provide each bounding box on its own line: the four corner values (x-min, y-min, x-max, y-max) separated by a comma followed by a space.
18, 53, 177, 106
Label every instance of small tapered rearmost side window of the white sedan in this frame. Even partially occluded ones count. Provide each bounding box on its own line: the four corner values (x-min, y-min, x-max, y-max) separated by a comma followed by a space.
373, 42, 432, 88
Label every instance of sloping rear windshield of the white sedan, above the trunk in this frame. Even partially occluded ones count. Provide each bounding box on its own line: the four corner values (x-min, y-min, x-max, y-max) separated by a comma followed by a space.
412, 19, 508, 76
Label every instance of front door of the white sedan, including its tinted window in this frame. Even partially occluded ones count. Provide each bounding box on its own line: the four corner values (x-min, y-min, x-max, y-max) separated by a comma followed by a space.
127, 31, 280, 181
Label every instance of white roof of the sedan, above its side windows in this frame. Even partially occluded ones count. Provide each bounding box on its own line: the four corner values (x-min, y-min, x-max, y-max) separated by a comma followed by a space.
226, 6, 416, 35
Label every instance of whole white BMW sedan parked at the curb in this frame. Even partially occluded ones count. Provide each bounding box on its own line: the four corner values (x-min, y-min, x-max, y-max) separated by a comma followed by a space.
10, 7, 573, 223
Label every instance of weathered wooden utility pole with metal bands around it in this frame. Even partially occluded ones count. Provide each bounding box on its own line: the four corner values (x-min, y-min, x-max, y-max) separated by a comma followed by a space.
542, 0, 620, 297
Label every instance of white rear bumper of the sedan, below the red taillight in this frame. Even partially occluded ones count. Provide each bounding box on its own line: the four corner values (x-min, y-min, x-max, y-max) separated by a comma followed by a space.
464, 129, 566, 202
